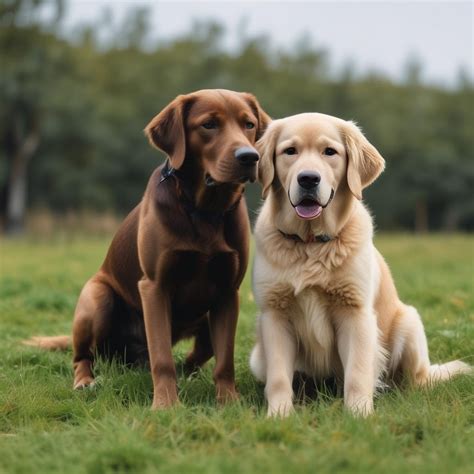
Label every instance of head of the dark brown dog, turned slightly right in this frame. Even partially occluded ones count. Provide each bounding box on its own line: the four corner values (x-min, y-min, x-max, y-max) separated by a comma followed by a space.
145, 89, 270, 186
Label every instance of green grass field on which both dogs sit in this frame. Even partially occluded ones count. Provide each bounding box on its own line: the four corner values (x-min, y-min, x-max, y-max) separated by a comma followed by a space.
0, 235, 474, 474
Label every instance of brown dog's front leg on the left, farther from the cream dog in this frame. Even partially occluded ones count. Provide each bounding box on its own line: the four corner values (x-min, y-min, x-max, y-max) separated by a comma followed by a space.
138, 279, 178, 410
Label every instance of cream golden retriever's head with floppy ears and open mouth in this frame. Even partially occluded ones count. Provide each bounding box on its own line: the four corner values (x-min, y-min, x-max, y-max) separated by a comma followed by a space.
257, 113, 385, 220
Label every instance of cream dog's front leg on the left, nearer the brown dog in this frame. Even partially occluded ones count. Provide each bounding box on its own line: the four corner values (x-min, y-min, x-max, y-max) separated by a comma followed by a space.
260, 311, 296, 417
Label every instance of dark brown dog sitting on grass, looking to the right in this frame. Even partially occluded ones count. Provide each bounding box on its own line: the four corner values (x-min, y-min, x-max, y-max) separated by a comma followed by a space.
25, 90, 270, 408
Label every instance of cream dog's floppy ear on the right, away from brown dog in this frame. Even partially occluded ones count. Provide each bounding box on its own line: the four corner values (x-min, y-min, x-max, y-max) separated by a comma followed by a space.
343, 122, 385, 200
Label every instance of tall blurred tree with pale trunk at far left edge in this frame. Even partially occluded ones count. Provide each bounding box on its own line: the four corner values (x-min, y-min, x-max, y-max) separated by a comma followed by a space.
0, 0, 62, 234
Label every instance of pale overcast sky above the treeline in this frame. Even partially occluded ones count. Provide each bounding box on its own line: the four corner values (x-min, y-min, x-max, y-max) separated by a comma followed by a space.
62, 0, 474, 83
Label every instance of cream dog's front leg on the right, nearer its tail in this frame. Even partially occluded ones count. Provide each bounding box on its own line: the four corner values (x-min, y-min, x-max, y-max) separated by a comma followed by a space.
337, 308, 378, 416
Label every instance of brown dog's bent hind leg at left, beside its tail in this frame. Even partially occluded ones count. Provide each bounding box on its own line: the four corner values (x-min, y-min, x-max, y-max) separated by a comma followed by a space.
72, 277, 114, 389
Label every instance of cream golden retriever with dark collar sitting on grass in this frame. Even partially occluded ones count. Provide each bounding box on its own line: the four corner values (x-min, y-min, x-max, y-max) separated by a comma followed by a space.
250, 113, 472, 416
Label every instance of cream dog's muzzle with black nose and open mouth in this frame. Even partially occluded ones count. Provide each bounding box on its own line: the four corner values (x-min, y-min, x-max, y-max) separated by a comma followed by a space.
288, 170, 334, 219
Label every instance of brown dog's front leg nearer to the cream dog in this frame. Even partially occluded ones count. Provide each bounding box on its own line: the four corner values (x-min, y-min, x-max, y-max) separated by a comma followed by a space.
209, 291, 239, 403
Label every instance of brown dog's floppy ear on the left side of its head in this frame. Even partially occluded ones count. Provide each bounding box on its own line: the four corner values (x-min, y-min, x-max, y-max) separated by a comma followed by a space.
145, 95, 190, 169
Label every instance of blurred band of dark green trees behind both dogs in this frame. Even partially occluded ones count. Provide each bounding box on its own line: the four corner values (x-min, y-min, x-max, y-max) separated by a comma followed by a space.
0, 0, 474, 233
